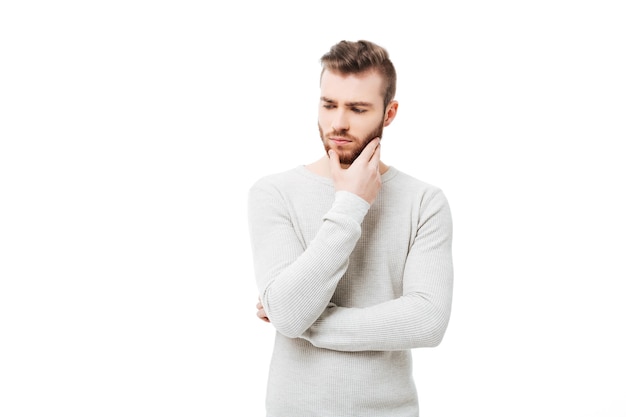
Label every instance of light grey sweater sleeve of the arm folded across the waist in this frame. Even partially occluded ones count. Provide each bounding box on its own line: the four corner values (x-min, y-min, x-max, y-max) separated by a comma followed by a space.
302, 191, 453, 351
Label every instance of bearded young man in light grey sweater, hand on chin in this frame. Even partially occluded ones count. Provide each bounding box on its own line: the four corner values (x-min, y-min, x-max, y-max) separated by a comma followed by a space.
249, 41, 453, 417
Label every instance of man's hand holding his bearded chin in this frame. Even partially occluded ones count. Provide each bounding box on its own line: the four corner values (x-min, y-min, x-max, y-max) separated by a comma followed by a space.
328, 138, 382, 204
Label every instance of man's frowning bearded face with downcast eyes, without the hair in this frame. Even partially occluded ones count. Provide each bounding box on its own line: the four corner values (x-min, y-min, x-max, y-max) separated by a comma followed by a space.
318, 71, 385, 165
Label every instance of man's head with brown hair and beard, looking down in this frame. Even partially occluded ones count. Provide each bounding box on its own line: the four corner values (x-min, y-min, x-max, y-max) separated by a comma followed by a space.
318, 40, 398, 165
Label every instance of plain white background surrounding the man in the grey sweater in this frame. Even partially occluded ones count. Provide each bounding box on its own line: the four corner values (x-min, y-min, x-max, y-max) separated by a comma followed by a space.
0, 0, 626, 417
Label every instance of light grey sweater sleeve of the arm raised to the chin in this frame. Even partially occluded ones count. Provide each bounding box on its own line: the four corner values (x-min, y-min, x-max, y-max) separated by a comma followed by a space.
248, 181, 369, 338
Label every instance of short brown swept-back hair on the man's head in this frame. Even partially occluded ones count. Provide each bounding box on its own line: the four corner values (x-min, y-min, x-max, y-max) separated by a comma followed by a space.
320, 40, 396, 107
